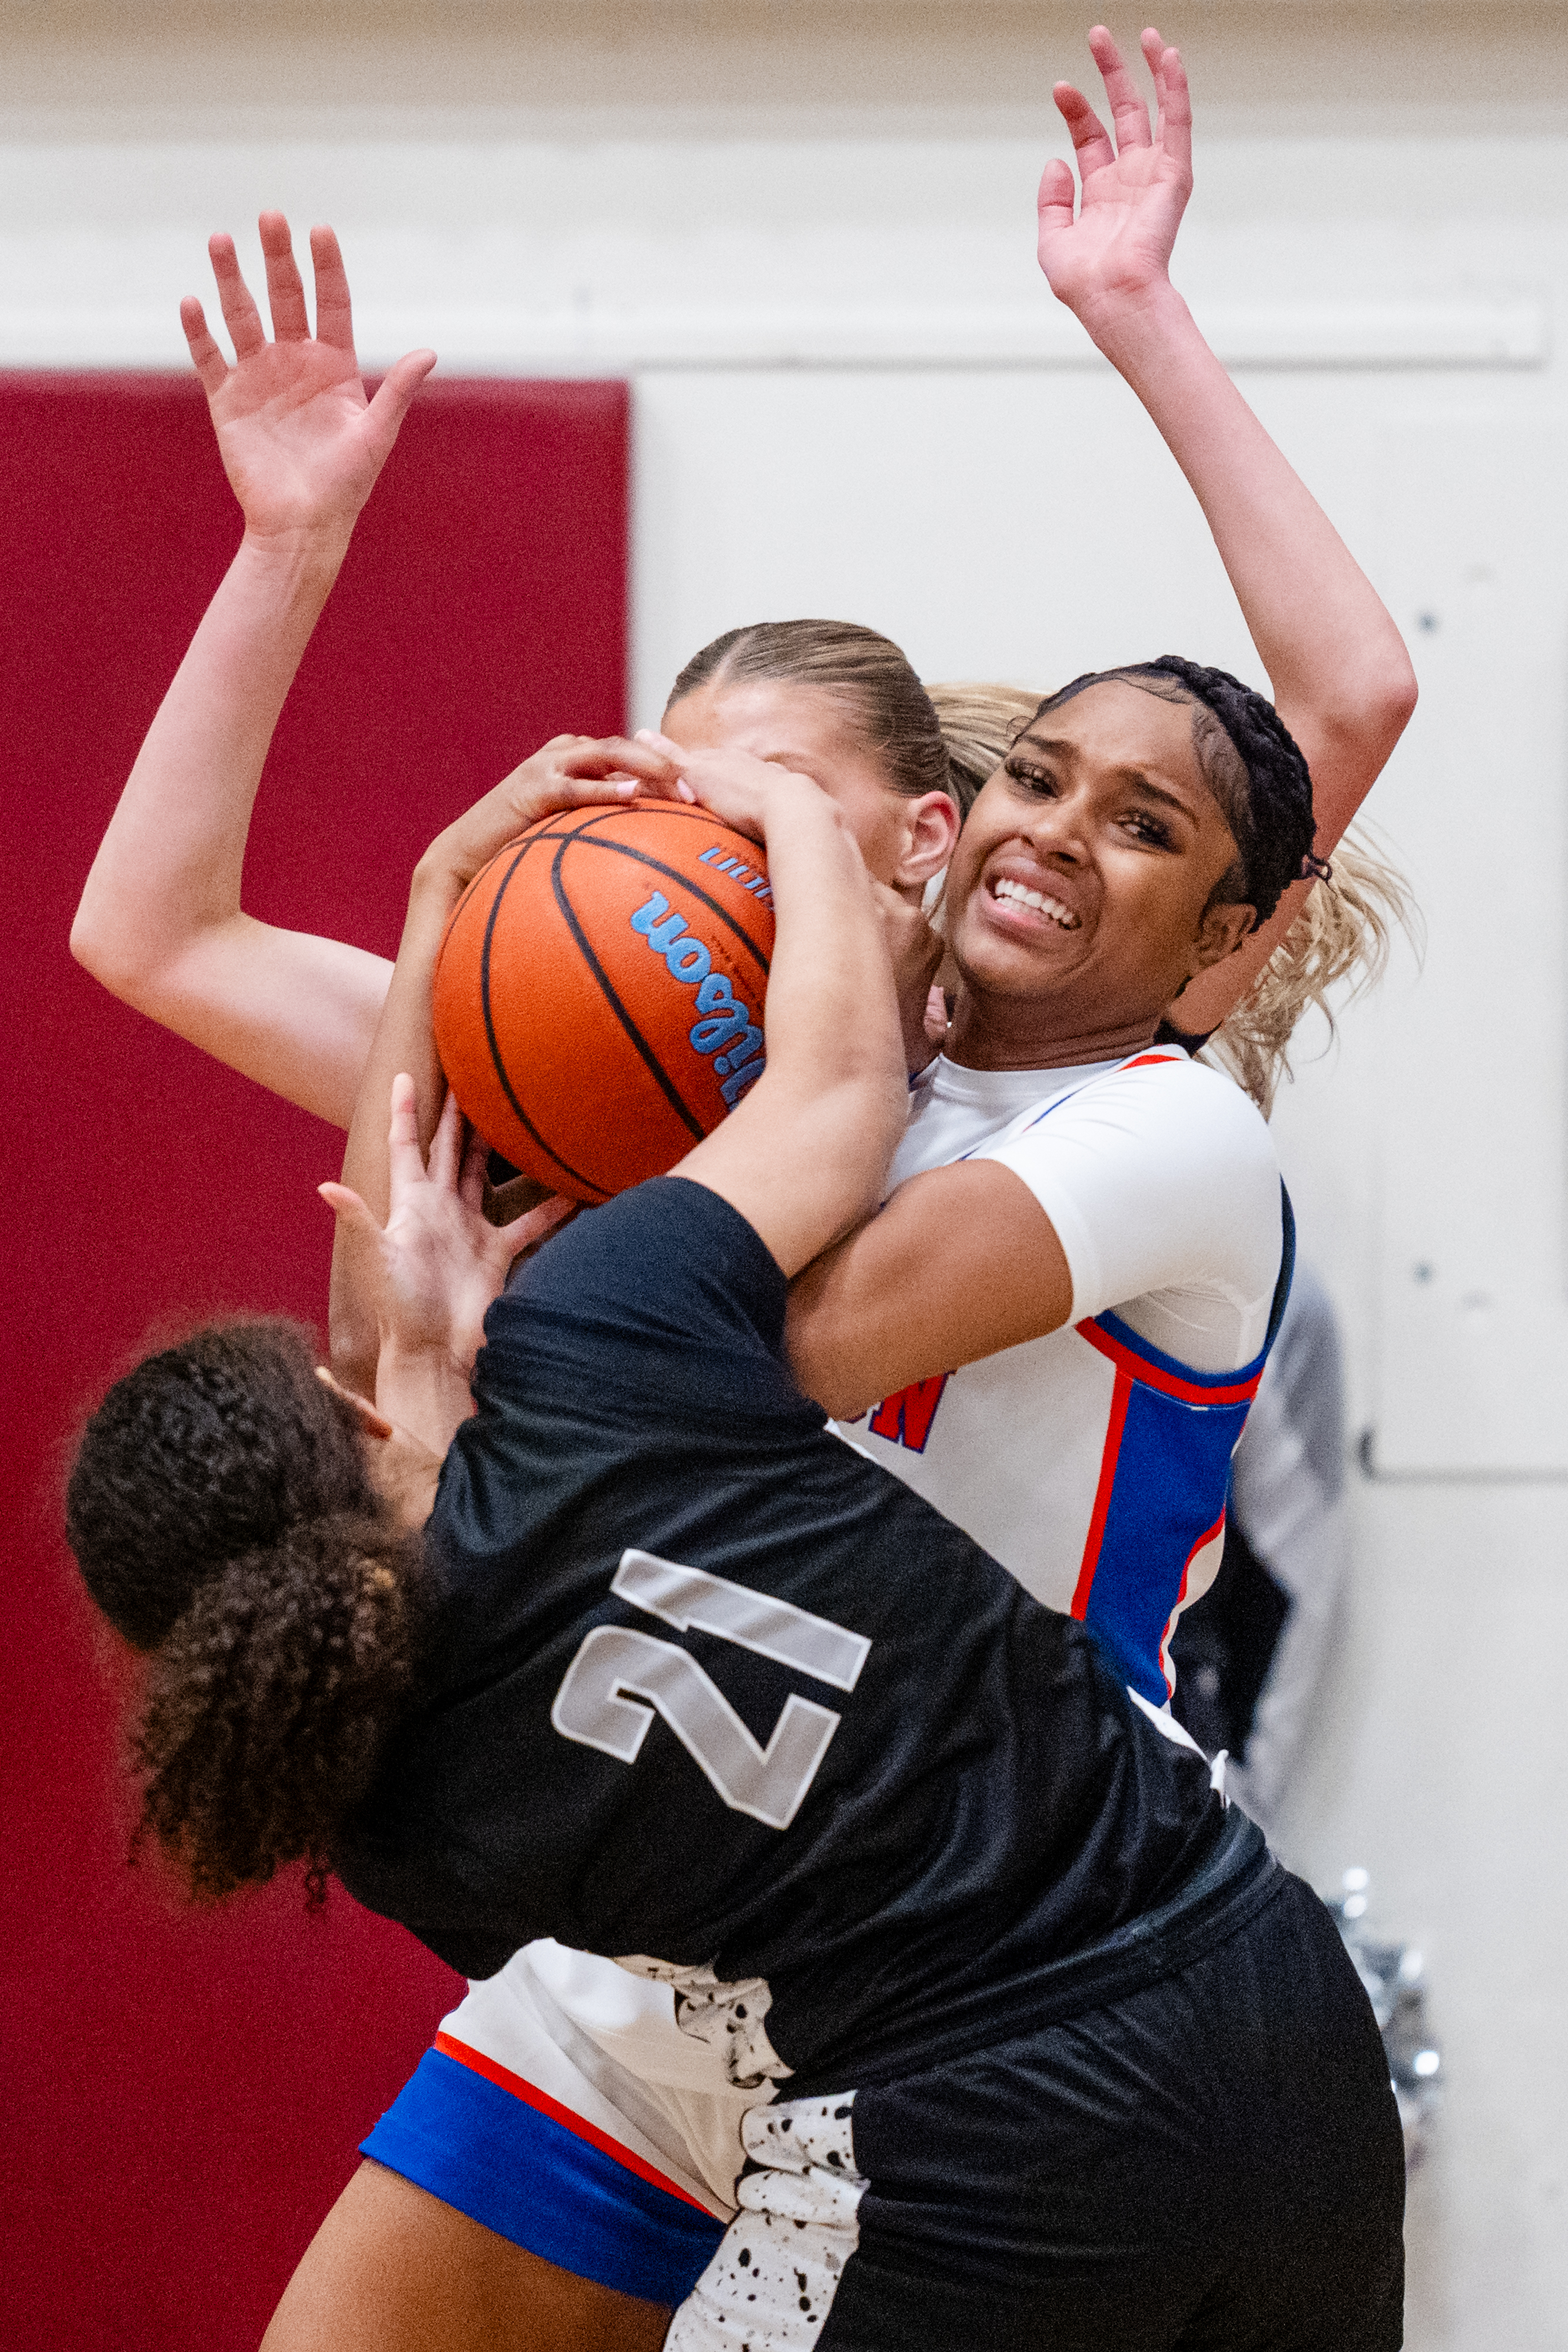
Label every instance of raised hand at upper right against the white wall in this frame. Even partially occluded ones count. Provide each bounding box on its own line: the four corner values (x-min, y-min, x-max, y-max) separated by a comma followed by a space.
1039, 24, 1192, 341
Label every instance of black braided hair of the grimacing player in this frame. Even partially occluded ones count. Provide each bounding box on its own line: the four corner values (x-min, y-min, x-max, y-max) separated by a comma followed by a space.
1037, 654, 1328, 924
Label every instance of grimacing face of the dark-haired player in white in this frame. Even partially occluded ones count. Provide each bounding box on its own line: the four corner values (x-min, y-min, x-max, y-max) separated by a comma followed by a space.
945, 680, 1251, 1037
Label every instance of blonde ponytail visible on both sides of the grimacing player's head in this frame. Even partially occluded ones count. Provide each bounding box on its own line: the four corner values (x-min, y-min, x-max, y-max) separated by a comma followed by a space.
926, 682, 1420, 1117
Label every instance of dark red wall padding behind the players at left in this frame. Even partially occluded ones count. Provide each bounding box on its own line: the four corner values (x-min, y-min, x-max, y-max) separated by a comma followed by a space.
0, 376, 628, 2352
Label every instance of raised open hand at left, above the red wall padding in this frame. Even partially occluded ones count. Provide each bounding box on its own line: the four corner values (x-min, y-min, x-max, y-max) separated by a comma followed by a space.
179, 212, 435, 541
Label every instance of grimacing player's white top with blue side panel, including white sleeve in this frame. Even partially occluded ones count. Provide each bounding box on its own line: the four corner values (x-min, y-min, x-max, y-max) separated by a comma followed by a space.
846, 1047, 1281, 1705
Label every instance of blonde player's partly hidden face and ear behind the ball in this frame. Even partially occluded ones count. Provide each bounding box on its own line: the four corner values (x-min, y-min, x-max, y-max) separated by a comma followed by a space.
661, 677, 957, 887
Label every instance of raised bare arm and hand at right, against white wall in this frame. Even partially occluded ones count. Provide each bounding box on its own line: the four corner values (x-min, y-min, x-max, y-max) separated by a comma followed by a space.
1039, 26, 1415, 1030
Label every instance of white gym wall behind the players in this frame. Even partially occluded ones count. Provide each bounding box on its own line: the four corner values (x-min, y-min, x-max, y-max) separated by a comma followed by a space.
0, 0, 1568, 2352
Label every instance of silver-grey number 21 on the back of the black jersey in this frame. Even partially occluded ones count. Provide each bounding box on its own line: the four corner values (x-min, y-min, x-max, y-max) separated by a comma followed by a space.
550, 1552, 872, 1830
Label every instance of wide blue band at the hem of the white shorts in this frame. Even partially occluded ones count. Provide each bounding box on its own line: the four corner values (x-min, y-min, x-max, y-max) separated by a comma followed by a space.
360, 2051, 724, 2303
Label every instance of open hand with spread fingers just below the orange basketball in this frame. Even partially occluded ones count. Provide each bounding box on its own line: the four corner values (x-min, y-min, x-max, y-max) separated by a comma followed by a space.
320, 1075, 574, 1378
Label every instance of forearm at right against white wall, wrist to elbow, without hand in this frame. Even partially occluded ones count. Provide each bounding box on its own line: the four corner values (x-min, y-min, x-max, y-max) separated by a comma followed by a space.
1084, 282, 1415, 851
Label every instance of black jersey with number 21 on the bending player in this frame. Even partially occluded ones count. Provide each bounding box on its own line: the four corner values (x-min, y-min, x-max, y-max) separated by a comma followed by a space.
336, 1178, 1222, 2082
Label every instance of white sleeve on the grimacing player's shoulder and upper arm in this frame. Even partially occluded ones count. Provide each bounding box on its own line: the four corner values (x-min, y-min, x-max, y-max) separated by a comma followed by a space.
975, 1054, 1281, 1371
